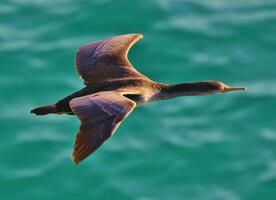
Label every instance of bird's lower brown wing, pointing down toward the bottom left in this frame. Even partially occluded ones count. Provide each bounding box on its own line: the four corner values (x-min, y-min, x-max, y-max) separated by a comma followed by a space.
70, 91, 136, 163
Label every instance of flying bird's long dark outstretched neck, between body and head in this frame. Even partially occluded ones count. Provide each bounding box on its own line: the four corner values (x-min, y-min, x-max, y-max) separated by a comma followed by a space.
152, 82, 217, 101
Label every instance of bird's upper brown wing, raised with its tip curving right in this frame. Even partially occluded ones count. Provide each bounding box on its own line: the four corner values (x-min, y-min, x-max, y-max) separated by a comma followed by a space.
75, 34, 146, 85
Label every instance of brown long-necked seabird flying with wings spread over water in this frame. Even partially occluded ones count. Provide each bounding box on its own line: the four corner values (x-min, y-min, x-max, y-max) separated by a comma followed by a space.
31, 33, 246, 164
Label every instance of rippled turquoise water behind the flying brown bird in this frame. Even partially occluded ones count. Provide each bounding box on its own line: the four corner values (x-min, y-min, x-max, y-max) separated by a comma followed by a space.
0, 0, 276, 200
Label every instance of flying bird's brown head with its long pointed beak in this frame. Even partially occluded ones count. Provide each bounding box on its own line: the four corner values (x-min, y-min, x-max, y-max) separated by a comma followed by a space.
204, 81, 246, 93
